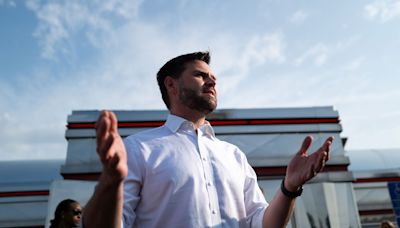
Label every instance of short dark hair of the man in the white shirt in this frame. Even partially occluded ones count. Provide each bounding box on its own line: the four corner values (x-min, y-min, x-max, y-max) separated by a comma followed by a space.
157, 52, 211, 109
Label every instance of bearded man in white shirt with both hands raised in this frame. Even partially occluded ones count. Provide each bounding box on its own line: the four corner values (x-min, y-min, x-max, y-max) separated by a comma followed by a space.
83, 52, 333, 228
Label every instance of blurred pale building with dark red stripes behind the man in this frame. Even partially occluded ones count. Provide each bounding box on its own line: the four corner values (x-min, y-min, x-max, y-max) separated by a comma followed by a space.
0, 106, 400, 228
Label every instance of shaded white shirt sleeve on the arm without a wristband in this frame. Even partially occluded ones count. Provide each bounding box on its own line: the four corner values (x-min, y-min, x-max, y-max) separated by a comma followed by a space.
122, 136, 145, 228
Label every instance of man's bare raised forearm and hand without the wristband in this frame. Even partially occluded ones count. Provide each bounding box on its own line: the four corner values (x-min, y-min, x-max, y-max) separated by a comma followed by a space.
82, 111, 128, 228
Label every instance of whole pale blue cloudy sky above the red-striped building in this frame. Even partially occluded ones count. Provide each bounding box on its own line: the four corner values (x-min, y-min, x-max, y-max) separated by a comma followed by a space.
0, 0, 400, 160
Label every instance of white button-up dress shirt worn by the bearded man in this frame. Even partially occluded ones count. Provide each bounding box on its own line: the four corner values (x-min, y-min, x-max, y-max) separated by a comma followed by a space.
123, 115, 268, 228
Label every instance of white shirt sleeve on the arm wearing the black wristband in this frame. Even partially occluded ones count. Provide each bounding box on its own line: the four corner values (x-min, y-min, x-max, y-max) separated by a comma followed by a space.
243, 151, 268, 228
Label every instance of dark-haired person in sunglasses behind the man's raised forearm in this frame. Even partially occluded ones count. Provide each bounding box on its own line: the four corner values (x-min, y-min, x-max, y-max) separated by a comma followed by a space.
50, 199, 82, 228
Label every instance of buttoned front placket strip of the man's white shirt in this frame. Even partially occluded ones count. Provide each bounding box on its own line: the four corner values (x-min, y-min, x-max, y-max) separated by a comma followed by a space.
197, 130, 221, 227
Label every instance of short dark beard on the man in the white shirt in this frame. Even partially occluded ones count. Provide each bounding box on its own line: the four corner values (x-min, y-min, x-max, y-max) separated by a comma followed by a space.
179, 84, 217, 115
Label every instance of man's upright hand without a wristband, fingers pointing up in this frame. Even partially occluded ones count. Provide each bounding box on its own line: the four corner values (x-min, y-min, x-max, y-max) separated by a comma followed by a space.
96, 111, 128, 185
